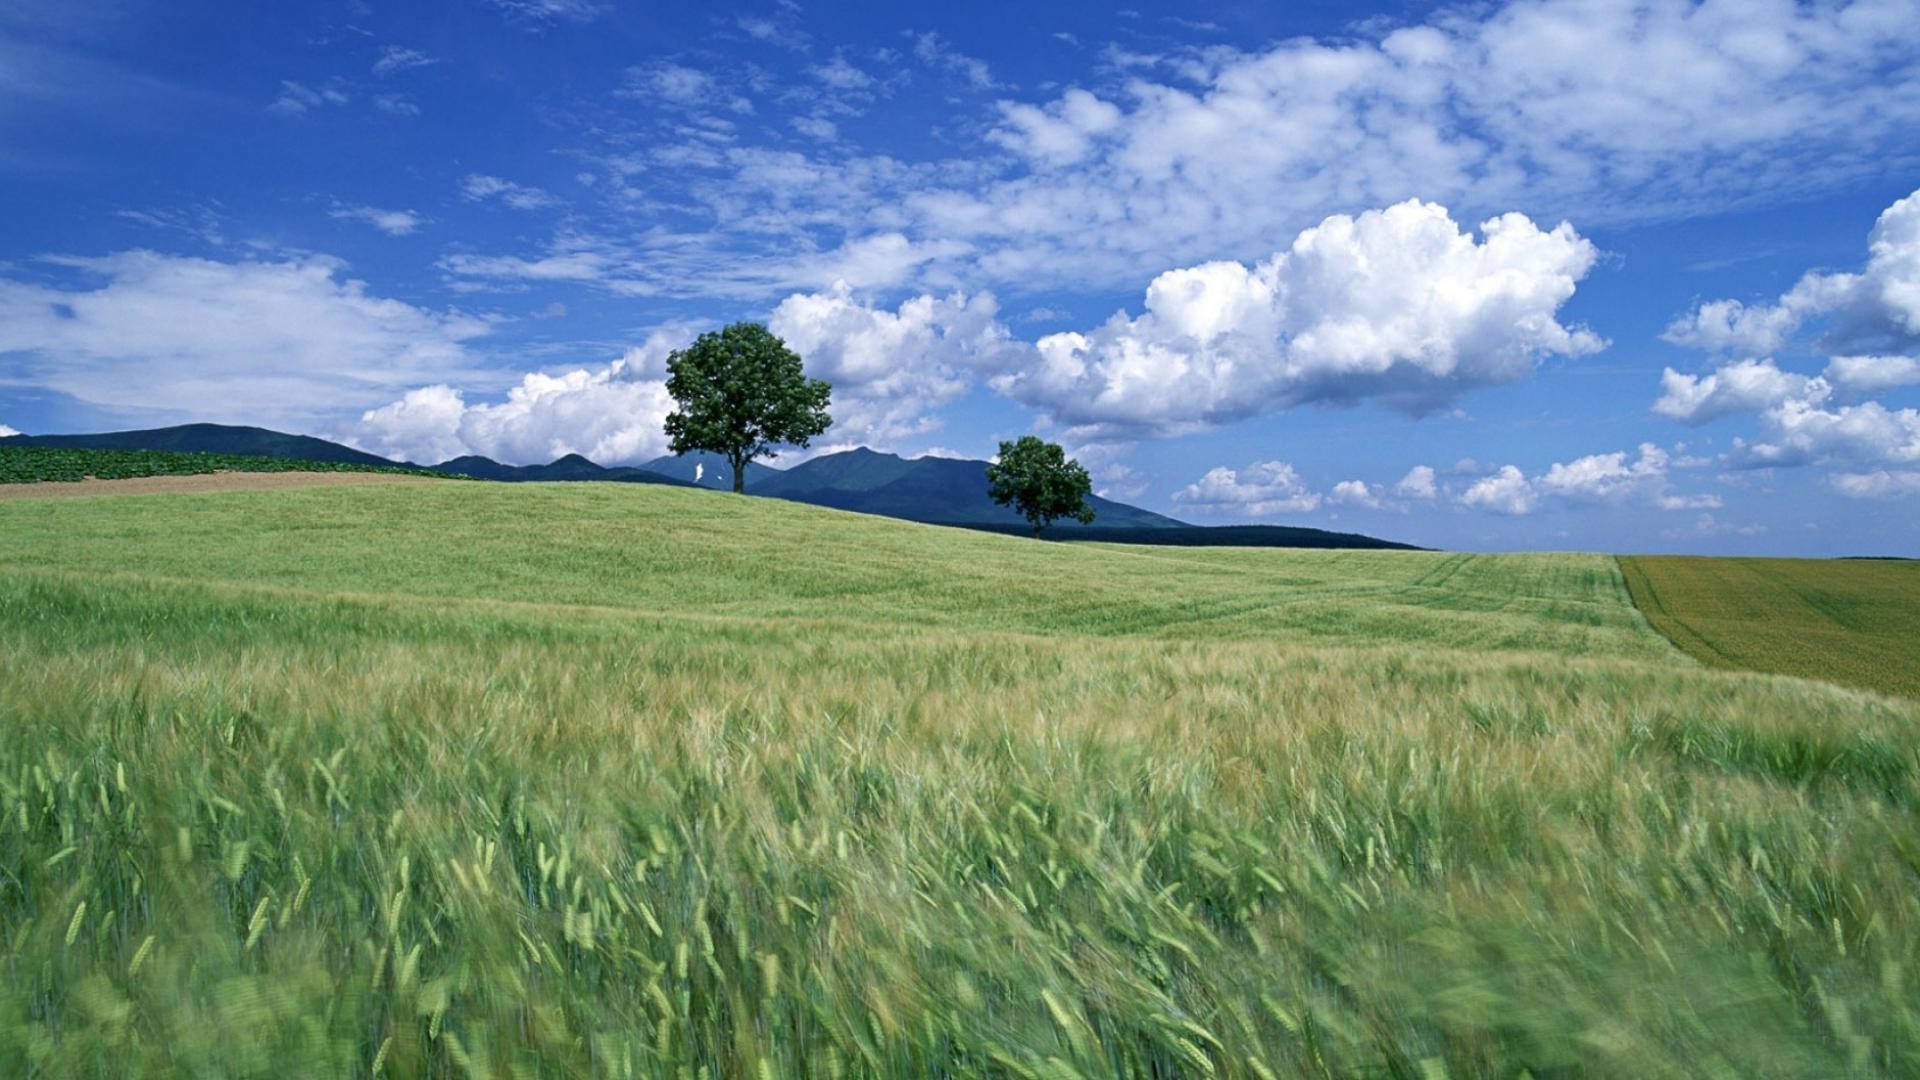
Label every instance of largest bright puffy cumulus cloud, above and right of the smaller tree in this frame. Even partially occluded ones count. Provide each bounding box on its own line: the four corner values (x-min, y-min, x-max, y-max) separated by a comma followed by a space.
995, 200, 1605, 436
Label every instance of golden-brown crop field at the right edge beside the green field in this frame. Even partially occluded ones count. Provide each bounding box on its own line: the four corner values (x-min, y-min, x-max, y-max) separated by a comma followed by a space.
1620, 555, 1920, 700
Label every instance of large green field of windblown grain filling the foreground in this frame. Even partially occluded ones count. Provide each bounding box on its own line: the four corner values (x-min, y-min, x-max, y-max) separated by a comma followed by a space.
0, 484, 1920, 1076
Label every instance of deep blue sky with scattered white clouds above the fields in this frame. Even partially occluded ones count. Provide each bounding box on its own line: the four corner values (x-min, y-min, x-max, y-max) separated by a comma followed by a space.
0, 0, 1920, 555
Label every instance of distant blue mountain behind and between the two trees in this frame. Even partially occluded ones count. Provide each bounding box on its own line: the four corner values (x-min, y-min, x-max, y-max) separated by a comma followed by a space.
747, 448, 1192, 530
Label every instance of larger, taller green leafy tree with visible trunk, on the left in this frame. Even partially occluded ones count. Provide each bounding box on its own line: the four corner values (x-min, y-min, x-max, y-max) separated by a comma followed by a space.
666, 323, 833, 492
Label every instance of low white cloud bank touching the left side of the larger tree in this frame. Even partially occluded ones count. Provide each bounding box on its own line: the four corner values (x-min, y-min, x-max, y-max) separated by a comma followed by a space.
349, 350, 674, 465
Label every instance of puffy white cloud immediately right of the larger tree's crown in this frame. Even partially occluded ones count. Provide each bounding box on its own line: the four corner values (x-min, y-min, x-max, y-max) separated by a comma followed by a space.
768, 282, 1031, 446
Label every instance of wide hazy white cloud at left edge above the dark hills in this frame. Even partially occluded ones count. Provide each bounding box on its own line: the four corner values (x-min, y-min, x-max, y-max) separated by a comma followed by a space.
0, 252, 490, 425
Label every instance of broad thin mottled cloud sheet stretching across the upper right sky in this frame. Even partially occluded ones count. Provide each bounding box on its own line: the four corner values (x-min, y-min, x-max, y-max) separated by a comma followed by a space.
879, 0, 1920, 282
